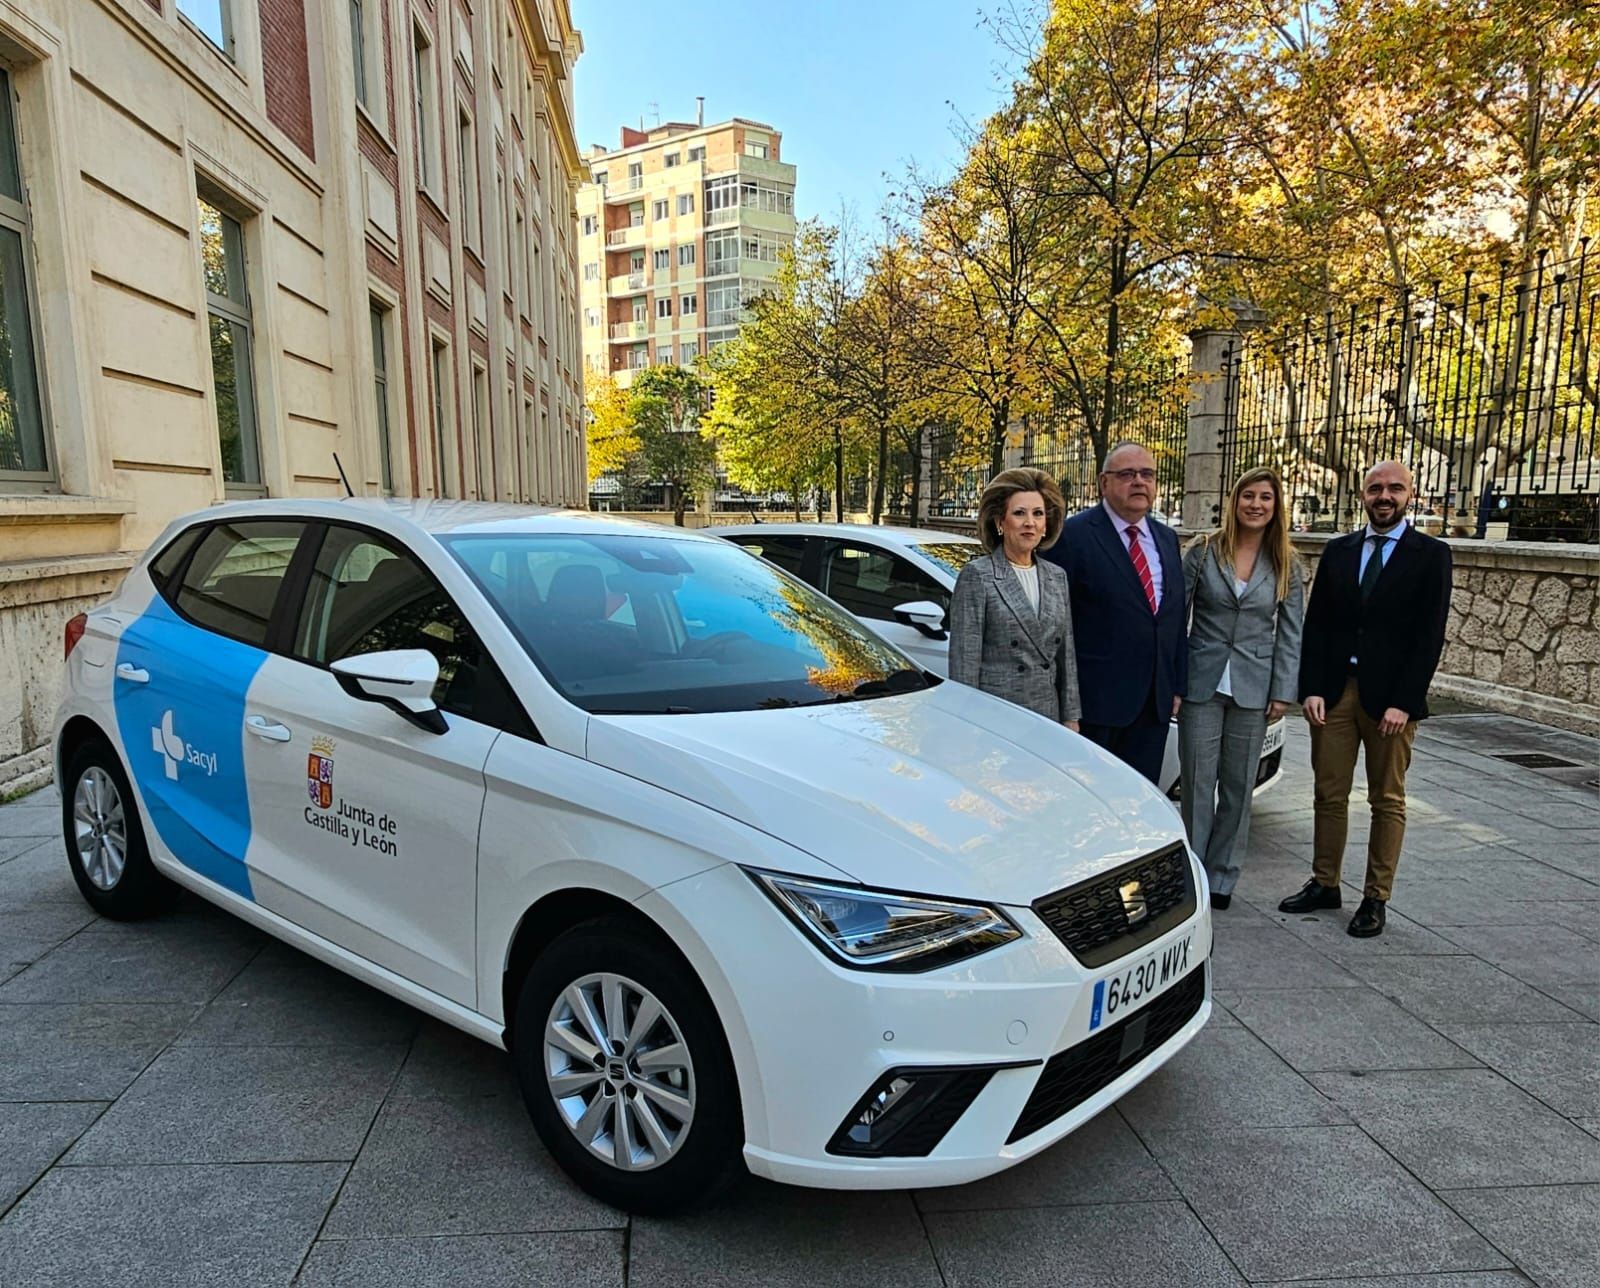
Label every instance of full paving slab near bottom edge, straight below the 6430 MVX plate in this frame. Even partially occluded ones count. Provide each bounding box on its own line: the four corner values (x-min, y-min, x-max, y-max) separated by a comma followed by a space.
928, 1203, 1245, 1288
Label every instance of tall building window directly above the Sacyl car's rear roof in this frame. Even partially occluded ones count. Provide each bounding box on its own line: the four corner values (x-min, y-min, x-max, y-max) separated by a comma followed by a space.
198, 192, 261, 488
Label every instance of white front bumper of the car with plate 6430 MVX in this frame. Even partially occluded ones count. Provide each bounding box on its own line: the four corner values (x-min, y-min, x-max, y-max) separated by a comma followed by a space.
640, 858, 1211, 1189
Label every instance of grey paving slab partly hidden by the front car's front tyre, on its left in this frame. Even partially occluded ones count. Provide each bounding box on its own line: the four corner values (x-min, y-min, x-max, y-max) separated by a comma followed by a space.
323, 1096, 627, 1238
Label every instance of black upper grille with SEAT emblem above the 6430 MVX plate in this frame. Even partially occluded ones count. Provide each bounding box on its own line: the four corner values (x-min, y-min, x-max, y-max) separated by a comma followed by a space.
1034, 842, 1197, 966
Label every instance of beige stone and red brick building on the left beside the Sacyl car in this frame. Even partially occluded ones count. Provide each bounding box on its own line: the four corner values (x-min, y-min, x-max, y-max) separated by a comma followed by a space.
0, 0, 586, 790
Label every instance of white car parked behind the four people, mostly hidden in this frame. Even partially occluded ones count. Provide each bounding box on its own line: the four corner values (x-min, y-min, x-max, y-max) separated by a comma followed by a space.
712, 523, 1285, 800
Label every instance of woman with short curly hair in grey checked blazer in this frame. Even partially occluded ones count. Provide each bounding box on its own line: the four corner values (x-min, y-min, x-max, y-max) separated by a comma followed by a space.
950, 469, 1083, 730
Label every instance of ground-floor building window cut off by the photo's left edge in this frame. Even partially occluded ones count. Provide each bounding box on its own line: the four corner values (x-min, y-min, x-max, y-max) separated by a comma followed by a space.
0, 69, 50, 478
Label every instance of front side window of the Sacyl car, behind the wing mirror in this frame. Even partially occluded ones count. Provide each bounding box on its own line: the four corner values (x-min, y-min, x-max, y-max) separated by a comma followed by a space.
294, 525, 483, 718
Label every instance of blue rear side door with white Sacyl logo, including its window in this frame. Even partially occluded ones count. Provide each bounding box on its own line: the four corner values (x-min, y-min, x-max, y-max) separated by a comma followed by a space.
112, 518, 307, 899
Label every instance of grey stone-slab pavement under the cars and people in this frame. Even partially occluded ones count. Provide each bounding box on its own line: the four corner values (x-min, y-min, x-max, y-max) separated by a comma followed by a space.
0, 715, 1600, 1288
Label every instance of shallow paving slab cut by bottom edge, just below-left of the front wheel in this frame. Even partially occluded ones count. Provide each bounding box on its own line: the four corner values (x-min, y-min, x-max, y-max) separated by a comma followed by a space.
294, 1230, 627, 1288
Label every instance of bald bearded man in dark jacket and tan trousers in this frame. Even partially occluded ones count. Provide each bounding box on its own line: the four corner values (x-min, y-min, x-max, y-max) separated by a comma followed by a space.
1278, 461, 1450, 938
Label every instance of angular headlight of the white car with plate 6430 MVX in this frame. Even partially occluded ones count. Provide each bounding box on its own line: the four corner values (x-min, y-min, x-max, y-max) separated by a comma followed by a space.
746, 869, 1022, 971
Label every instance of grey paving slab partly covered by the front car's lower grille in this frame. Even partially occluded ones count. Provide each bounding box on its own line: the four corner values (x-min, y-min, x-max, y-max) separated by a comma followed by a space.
914, 1109, 1178, 1213
